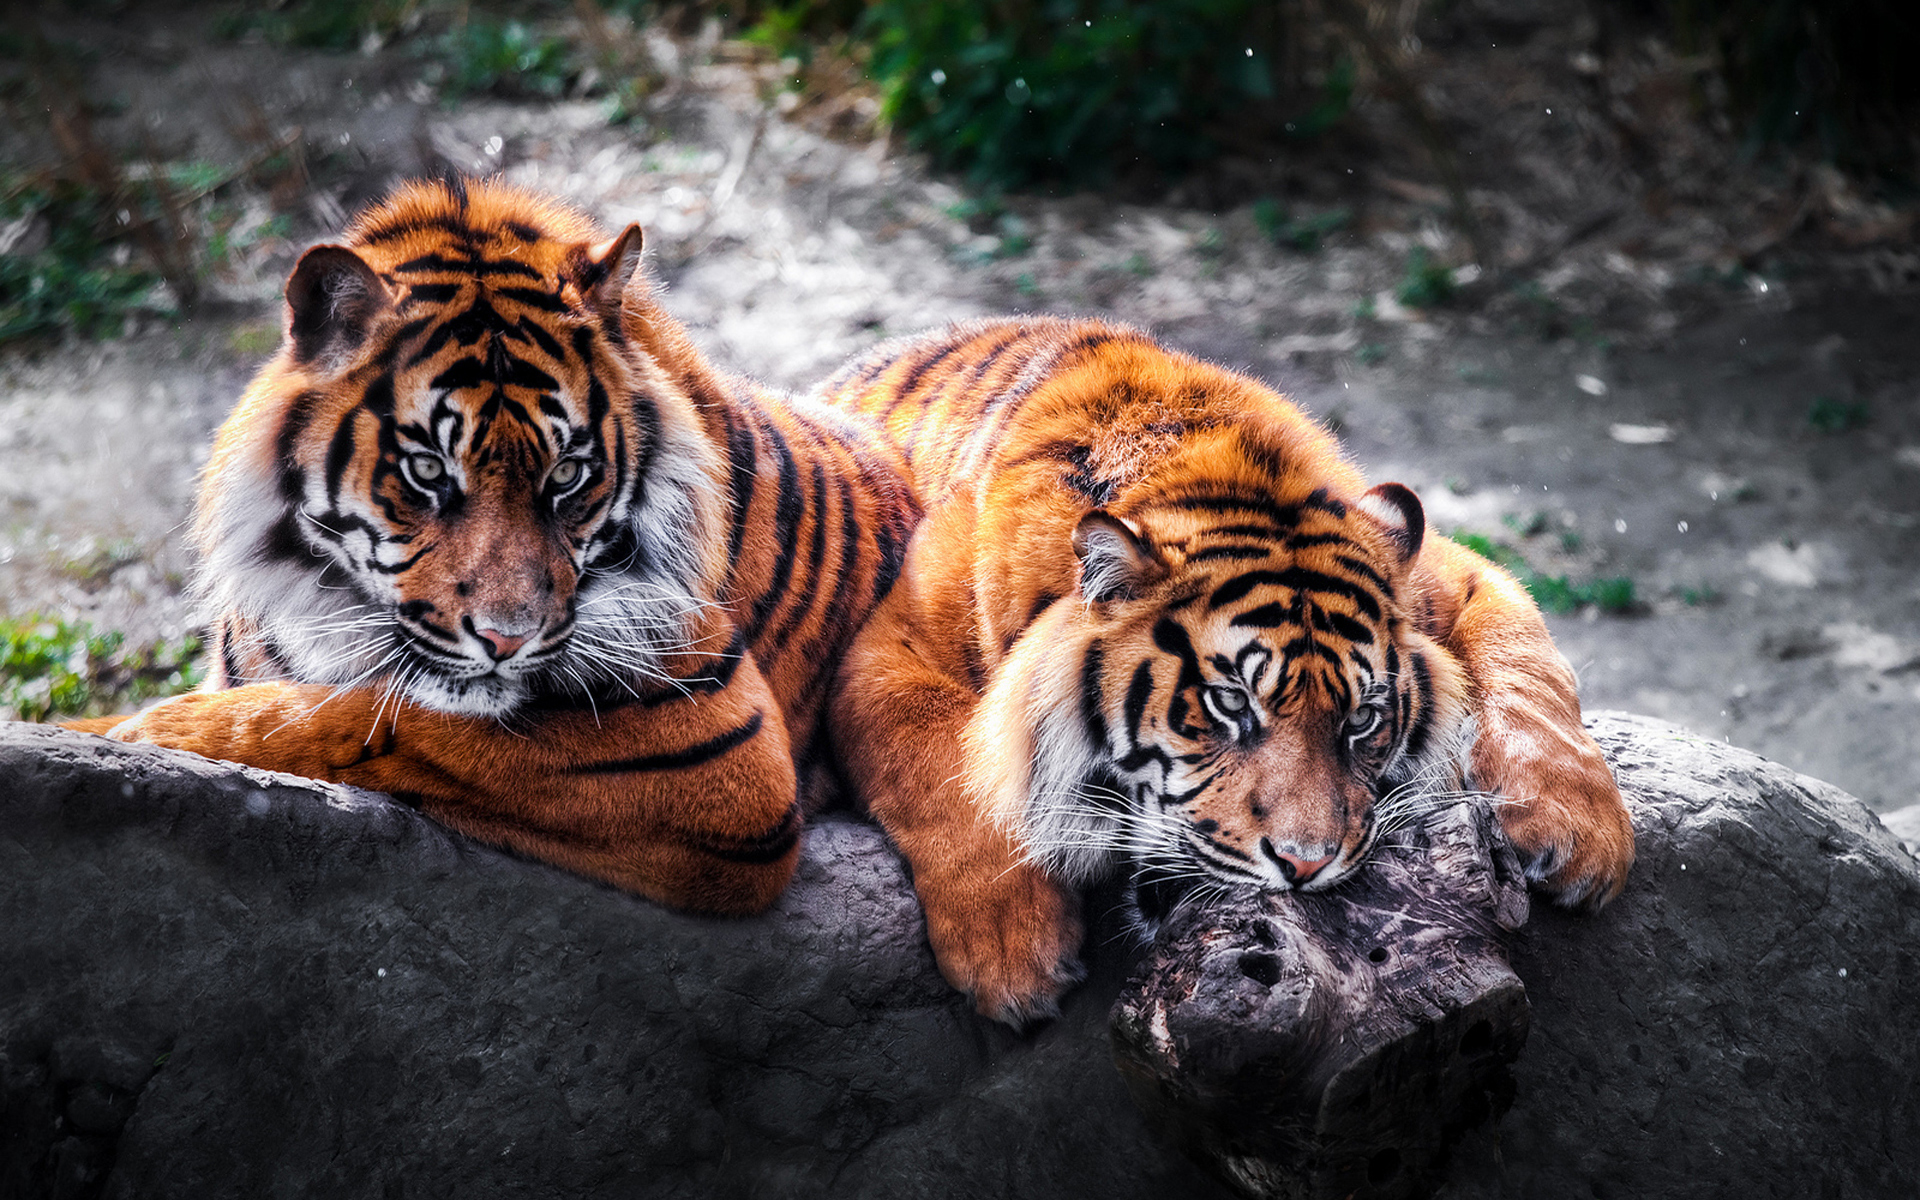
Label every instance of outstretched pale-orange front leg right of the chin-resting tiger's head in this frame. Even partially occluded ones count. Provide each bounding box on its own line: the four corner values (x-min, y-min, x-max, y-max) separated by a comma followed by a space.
1423, 540, 1634, 910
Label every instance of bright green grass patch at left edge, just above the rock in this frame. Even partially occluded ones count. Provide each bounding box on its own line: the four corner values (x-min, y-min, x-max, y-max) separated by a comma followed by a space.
0, 616, 204, 720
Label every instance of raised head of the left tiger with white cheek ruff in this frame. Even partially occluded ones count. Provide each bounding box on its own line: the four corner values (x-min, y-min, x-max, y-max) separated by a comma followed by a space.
194, 182, 718, 716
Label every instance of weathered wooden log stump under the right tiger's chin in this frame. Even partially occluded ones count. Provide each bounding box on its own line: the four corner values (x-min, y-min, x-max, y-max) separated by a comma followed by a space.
1110, 801, 1528, 1200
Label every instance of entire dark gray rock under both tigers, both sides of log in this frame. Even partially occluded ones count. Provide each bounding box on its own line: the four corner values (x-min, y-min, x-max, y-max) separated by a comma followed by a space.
0, 714, 1920, 1200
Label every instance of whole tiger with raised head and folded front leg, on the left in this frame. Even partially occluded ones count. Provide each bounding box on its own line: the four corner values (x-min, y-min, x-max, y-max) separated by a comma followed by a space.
63, 180, 918, 912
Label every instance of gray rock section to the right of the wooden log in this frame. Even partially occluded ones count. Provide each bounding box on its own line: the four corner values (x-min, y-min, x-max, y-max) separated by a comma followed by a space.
1440, 714, 1920, 1200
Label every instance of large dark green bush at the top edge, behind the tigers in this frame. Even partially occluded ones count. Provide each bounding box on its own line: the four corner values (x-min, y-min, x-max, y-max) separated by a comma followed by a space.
856, 0, 1346, 188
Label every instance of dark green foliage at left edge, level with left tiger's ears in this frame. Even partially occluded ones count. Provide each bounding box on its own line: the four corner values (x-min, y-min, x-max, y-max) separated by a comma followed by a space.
0, 175, 156, 346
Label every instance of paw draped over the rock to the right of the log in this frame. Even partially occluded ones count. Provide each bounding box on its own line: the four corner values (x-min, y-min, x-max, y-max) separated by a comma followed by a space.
1475, 732, 1634, 912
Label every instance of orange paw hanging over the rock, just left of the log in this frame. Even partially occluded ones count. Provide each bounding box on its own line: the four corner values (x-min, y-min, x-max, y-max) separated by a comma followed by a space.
918, 862, 1087, 1029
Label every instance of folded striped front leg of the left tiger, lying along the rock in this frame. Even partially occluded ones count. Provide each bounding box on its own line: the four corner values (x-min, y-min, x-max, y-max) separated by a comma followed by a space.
80, 659, 803, 914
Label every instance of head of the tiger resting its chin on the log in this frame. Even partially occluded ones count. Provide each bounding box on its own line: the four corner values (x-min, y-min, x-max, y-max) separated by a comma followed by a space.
968, 439, 1469, 918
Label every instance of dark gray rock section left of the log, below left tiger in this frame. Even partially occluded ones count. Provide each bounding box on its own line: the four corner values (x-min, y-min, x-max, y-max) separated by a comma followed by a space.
0, 726, 1221, 1200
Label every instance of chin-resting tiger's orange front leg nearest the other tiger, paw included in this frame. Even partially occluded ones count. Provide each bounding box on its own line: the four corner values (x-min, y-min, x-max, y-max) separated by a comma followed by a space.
831, 582, 1085, 1029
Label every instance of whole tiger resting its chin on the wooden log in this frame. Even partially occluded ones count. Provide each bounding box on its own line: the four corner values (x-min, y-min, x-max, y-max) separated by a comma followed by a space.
822, 319, 1634, 1025
